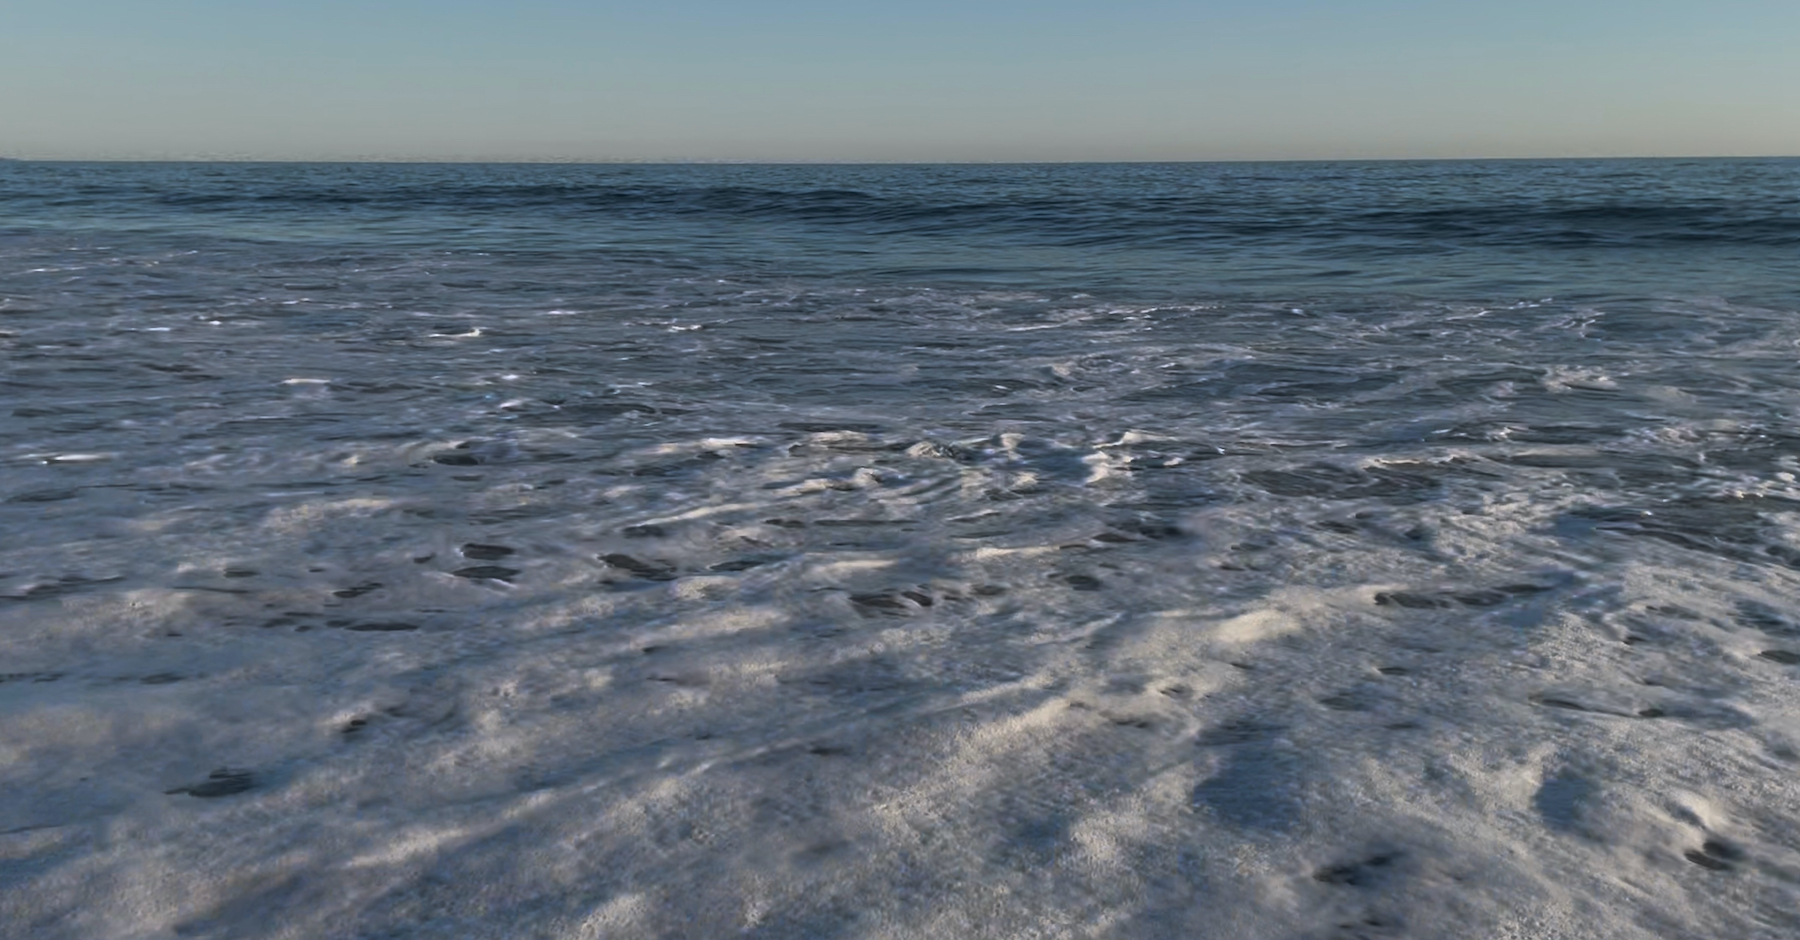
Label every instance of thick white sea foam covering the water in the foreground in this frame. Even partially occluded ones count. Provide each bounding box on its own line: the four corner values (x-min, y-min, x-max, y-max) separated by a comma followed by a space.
0, 403, 1800, 936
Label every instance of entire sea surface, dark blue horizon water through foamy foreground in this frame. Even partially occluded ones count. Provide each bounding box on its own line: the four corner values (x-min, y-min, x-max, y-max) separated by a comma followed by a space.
0, 160, 1800, 940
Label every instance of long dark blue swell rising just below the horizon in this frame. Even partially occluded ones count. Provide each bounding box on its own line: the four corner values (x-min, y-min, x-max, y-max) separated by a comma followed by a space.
133, 184, 1800, 249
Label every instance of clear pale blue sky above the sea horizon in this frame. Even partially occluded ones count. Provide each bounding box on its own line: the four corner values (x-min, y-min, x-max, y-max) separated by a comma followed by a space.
0, 0, 1800, 162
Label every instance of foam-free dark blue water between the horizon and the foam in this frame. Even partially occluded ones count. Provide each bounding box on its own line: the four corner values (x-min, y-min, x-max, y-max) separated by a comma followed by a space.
0, 158, 1800, 306
